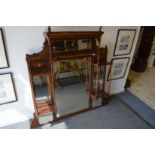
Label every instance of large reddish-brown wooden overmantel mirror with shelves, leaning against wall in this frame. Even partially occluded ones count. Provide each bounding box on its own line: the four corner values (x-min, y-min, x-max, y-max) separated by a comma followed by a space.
26, 27, 111, 127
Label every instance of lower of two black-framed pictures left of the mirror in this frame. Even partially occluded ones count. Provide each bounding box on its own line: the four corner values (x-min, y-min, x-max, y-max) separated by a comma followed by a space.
0, 73, 17, 105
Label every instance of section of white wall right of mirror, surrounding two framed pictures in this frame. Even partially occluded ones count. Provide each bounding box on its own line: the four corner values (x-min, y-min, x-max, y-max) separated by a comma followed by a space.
102, 26, 140, 94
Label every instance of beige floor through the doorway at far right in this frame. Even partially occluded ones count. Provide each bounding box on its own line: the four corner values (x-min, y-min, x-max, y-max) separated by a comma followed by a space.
128, 66, 155, 110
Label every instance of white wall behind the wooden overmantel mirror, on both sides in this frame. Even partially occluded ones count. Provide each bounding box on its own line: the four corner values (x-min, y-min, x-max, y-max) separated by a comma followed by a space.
0, 26, 140, 127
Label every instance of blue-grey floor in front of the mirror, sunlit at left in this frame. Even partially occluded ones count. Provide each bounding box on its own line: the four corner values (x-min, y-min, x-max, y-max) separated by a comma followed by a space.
0, 88, 152, 129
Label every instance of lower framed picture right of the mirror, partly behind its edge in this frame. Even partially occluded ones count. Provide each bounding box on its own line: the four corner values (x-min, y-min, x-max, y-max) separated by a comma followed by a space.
108, 57, 130, 81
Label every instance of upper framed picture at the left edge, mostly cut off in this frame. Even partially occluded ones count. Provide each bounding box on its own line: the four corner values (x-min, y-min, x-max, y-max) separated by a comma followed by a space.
0, 28, 9, 69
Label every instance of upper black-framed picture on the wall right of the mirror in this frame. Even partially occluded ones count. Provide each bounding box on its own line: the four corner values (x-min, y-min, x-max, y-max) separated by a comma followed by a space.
114, 29, 136, 56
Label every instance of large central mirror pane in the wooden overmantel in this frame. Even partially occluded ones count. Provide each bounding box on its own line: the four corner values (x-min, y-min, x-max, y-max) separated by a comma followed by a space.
54, 58, 89, 117
